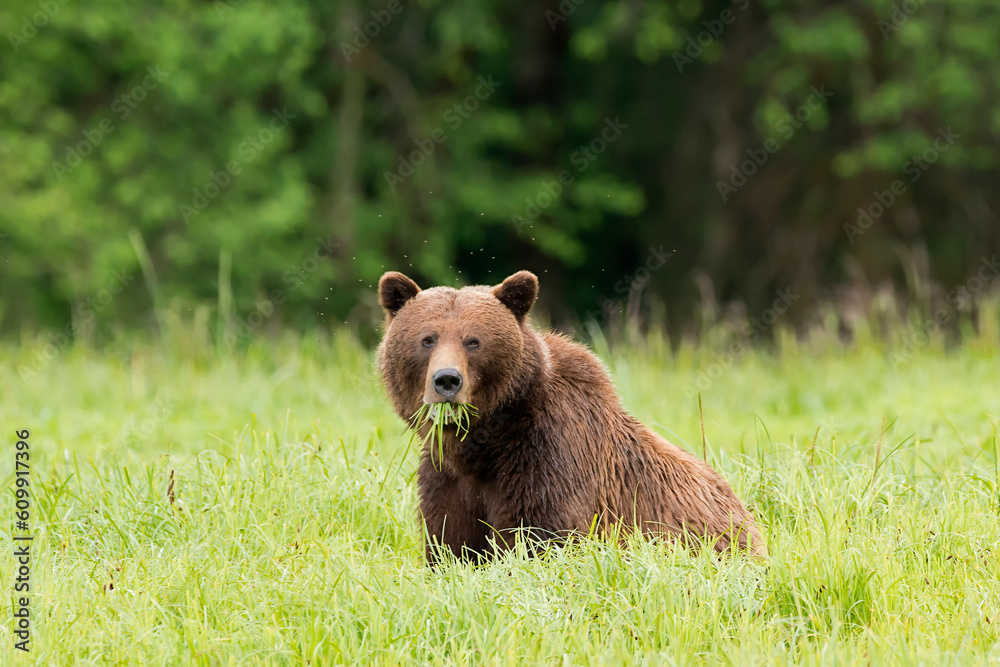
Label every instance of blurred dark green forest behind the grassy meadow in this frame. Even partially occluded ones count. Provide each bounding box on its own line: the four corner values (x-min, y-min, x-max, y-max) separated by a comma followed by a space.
0, 0, 1000, 344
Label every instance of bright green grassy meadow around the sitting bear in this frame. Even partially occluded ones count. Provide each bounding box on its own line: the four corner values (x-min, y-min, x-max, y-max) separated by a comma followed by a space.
0, 312, 1000, 665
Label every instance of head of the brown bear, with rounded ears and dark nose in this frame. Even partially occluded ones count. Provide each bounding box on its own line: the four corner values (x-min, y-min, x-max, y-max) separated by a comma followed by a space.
378, 271, 538, 419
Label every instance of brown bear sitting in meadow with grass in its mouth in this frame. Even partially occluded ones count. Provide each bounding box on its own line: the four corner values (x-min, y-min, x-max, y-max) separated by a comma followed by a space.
378, 271, 765, 565
